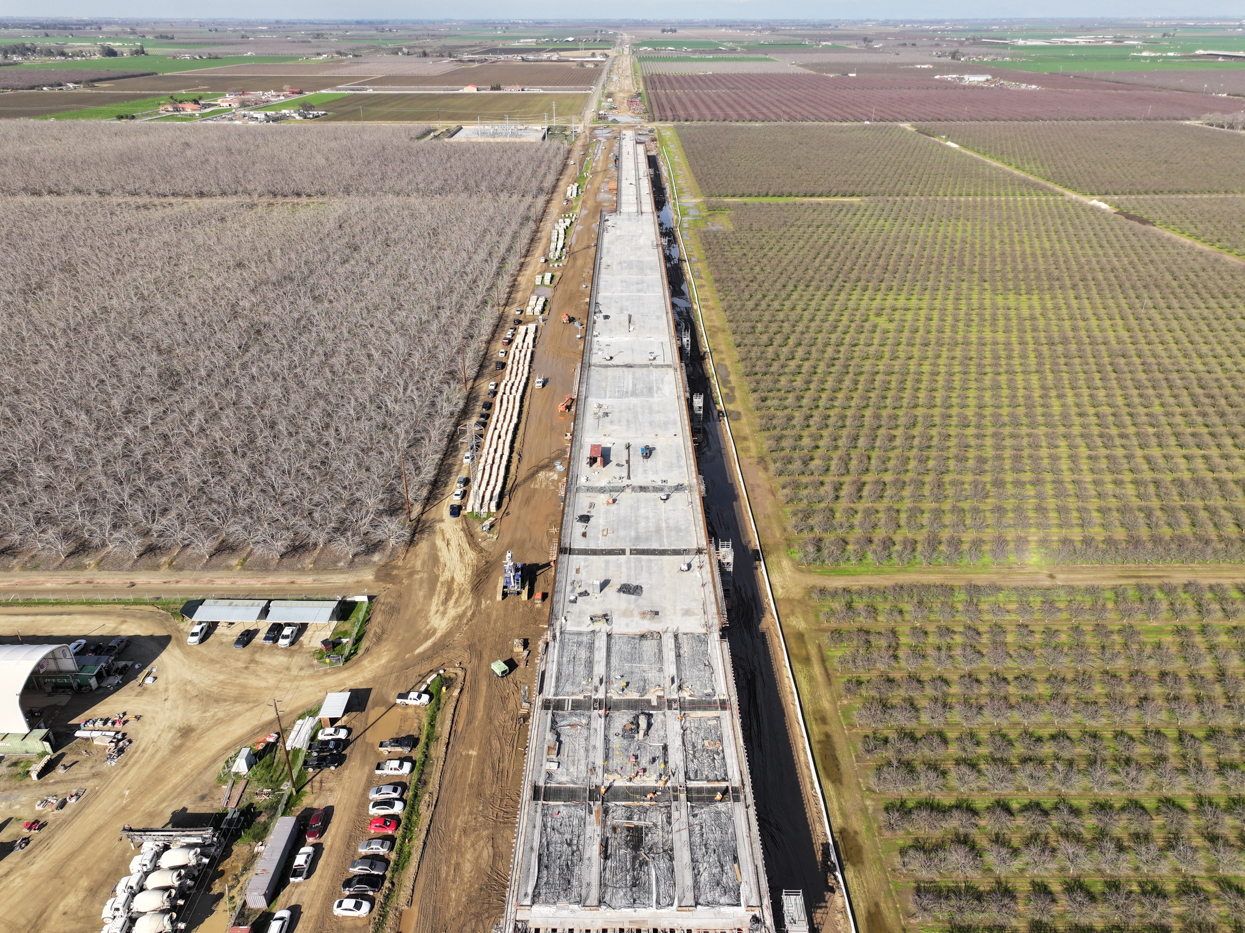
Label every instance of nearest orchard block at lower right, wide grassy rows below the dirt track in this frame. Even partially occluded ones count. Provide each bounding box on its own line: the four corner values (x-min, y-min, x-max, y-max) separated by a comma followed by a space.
809, 582, 1245, 931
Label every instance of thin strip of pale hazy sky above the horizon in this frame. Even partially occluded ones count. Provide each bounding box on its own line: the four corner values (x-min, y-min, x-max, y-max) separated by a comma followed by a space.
9, 0, 1245, 20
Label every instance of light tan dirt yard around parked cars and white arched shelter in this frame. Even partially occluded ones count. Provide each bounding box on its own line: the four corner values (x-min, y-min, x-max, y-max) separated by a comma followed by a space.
0, 607, 450, 933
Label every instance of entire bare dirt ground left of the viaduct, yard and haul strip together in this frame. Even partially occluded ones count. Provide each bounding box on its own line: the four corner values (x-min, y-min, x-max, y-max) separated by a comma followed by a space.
0, 128, 613, 933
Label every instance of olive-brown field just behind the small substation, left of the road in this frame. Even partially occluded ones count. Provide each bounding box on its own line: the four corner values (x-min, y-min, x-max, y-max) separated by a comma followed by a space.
311, 93, 588, 123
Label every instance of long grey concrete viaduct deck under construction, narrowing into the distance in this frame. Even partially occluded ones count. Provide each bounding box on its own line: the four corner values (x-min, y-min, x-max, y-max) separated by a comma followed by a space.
504, 132, 774, 931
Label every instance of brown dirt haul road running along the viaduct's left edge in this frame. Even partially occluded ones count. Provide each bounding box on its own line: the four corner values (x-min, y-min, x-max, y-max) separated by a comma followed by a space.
402, 131, 614, 933
